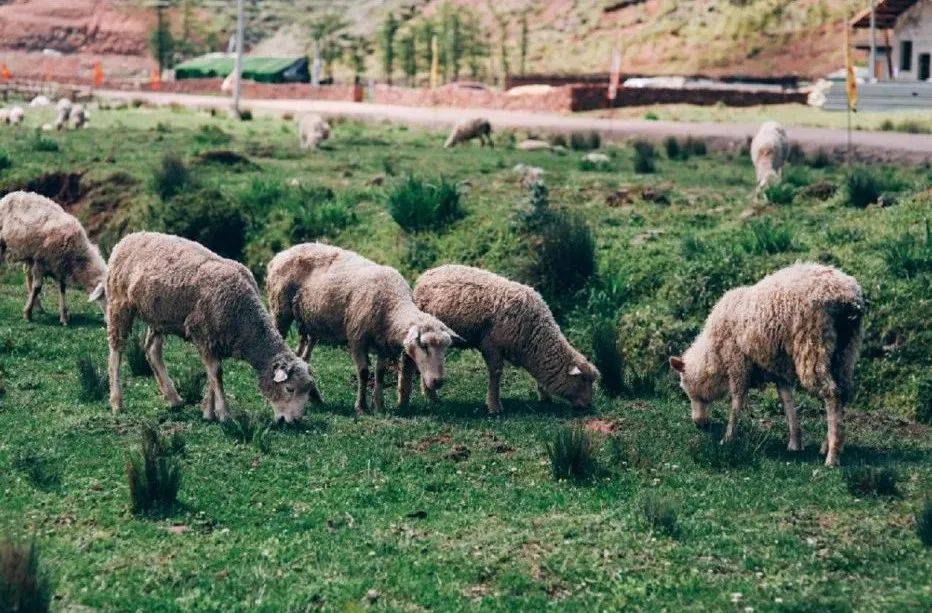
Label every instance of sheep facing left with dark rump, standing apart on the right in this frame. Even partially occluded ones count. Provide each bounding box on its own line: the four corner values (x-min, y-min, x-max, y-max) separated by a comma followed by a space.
670, 263, 864, 466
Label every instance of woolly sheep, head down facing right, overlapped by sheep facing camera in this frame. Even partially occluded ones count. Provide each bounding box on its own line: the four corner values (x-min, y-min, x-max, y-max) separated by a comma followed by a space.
414, 265, 599, 413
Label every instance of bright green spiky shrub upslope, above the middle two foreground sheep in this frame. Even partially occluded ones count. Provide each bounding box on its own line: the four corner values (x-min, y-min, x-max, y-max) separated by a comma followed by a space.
387, 174, 463, 232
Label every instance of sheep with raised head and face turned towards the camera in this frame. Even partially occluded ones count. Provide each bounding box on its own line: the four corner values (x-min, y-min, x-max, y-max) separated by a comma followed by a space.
266, 243, 460, 415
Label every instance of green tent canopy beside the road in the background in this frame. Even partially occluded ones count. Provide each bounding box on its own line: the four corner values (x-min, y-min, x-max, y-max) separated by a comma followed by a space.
175, 55, 311, 83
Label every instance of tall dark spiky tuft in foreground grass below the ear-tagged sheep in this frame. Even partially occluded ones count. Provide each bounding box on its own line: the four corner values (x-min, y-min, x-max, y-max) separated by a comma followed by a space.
126, 424, 181, 514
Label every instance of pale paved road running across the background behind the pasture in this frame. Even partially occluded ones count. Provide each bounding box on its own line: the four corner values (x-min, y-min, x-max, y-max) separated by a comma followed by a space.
96, 90, 932, 163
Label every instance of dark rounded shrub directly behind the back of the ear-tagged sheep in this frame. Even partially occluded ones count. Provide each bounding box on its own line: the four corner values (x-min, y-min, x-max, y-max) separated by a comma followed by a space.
155, 188, 249, 260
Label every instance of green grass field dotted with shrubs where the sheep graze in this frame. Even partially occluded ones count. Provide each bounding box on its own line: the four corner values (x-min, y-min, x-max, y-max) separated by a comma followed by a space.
0, 108, 932, 611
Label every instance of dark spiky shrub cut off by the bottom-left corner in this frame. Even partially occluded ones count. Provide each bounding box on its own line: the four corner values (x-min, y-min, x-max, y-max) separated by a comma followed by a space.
0, 540, 54, 613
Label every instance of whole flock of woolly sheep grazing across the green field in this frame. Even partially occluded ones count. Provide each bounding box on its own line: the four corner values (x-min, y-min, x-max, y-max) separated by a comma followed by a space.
0, 110, 865, 466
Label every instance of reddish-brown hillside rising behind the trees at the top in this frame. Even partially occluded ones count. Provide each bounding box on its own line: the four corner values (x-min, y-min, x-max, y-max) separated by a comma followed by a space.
0, 0, 863, 77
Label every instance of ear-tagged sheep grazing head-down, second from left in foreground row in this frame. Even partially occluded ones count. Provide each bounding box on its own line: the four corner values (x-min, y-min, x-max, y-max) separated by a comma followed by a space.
107, 232, 322, 423
